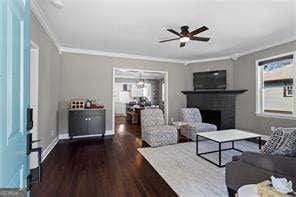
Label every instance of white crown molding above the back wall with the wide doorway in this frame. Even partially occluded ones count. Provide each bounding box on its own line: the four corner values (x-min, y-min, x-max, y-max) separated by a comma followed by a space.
60, 47, 186, 64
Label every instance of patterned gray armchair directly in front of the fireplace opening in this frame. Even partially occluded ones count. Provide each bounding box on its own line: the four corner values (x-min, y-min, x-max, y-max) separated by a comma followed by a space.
181, 108, 217, 140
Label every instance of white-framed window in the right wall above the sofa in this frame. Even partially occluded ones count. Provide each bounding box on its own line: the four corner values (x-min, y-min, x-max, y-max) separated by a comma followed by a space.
256, 53, 296, 117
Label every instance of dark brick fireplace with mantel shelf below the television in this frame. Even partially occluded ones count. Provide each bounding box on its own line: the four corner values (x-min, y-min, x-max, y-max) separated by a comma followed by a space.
182, 90, 247, 130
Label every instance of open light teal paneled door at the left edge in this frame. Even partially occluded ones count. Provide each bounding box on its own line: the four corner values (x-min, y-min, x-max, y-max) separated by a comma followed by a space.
0, 0, 30, 189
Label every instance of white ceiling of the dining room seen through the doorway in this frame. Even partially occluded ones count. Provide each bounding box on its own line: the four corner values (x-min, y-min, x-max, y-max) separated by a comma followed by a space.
115, 69, 164, 79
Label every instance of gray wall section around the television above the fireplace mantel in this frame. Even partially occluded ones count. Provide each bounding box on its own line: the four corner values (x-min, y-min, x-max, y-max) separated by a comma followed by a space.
187, 59, 234, 90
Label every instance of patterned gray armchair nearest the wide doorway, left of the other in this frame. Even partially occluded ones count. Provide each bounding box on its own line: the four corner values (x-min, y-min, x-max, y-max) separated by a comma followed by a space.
141, 109, 178, 147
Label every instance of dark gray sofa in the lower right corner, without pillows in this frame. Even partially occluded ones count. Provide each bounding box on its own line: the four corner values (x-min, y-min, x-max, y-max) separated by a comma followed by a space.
225, 152, 296, 196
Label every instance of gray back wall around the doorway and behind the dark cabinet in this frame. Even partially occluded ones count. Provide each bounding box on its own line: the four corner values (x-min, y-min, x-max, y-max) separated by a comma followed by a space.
59, 53, 187, 133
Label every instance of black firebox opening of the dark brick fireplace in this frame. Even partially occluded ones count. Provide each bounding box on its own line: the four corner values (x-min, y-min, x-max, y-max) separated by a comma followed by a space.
199, 109, 221, 130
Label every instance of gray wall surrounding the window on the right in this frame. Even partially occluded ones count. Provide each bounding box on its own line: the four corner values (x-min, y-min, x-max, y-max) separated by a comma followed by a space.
234, 41, 296, 135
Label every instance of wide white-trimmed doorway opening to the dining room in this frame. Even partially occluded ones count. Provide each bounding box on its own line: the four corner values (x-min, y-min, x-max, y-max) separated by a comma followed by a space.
112, 68, 168, 132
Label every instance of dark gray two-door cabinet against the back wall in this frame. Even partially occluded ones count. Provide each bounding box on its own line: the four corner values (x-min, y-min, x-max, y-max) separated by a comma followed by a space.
69, 109, 106, 138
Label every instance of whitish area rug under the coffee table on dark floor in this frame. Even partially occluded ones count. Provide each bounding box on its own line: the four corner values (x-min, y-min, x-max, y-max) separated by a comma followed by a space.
138, 141, 258, 197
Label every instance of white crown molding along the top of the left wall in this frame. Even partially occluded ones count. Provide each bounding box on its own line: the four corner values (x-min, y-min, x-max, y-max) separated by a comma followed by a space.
30, 0, 61, 54
